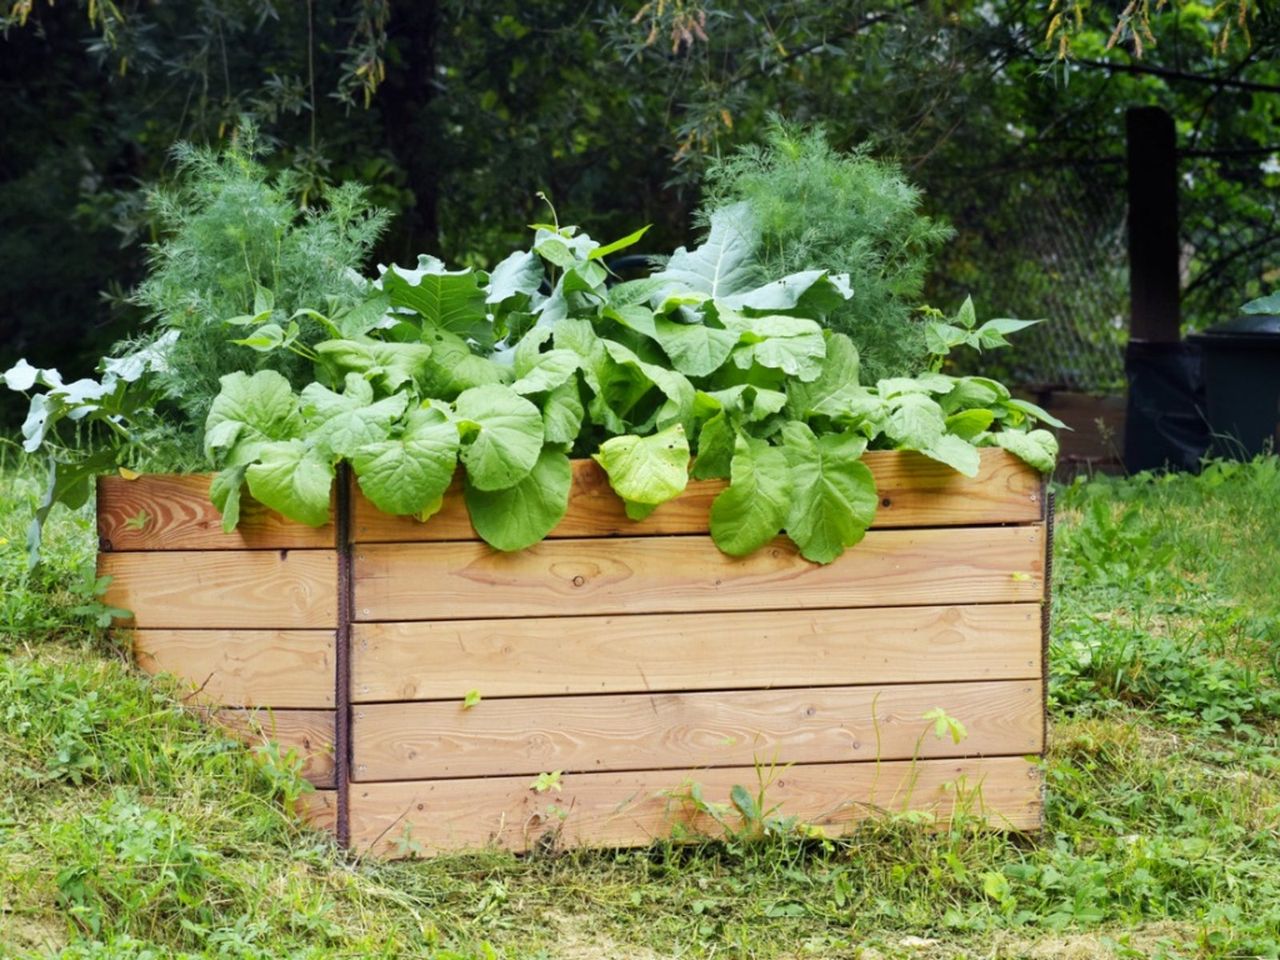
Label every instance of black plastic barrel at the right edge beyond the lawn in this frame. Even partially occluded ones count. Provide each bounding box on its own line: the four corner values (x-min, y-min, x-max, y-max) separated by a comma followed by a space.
1187, 316, 1280, 458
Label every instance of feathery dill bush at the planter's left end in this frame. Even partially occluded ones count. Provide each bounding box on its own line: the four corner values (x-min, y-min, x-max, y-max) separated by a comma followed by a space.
134, 136, 388, 433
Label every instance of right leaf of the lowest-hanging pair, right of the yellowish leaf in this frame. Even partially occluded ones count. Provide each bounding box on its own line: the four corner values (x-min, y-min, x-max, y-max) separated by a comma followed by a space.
782, 420, 877, 563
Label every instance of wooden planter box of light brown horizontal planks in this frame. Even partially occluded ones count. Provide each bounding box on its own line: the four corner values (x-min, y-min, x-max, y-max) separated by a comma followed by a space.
99, 449, 1051, 855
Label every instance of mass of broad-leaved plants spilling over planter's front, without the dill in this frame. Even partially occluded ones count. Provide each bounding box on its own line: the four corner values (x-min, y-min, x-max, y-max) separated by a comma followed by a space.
194, 204, 1056, 563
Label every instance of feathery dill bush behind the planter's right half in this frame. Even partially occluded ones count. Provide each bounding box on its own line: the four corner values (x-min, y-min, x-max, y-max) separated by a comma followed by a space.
699, 120, 954, 381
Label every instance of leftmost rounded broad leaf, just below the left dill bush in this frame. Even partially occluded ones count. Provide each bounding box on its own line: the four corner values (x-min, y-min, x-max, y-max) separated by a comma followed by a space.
205, 370, 302, 466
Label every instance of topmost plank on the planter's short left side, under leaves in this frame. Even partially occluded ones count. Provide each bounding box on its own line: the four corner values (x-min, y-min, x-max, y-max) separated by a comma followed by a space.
97, 474, 335, 550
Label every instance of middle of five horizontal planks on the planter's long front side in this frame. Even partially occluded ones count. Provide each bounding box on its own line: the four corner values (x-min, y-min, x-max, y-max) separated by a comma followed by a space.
351, 603, 1041, 703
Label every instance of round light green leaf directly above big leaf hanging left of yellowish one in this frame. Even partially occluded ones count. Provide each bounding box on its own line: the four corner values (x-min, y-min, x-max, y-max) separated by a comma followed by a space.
453, 384, 543, 490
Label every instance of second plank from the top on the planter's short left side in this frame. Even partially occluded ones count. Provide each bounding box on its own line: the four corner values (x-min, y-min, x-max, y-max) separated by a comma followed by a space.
97, 550, 338, 630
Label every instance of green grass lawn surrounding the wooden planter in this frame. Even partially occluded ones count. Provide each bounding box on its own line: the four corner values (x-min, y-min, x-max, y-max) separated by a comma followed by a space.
0, 447, 1280, 960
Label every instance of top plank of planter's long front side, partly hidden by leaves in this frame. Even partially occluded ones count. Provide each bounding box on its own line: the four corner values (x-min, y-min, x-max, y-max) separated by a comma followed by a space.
352, 448, 1043, 543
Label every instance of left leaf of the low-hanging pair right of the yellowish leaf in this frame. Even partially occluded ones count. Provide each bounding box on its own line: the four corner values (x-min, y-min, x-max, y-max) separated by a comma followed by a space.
710, 436, 791, 557
